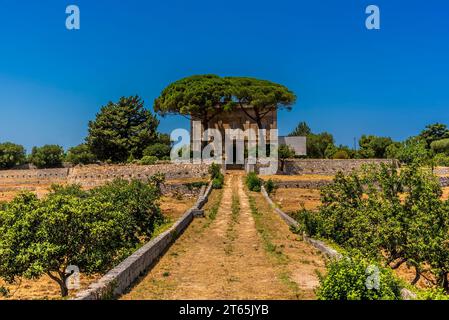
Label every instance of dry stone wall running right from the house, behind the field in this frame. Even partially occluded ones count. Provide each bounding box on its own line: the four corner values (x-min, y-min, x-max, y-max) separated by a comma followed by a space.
283, 159, 397, 175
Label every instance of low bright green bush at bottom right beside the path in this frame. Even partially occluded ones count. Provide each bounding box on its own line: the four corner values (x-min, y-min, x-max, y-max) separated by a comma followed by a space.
317, 256, 401, 300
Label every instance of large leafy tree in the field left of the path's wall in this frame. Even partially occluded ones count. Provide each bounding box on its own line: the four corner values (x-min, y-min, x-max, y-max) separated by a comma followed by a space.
0, 177, 163, 296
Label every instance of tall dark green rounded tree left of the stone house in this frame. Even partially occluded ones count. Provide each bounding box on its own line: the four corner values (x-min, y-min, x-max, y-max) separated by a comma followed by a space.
86, 96, 159, 162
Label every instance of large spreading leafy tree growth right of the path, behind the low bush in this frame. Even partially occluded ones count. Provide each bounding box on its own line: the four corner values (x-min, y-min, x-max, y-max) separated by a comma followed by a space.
295, 164, 449, 292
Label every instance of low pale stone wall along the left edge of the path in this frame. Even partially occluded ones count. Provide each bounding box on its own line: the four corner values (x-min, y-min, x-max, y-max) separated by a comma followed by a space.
75, 183, 212, 300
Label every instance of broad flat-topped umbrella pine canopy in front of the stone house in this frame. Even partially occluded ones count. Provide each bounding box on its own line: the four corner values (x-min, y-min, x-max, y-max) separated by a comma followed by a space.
154, 75, 296, 130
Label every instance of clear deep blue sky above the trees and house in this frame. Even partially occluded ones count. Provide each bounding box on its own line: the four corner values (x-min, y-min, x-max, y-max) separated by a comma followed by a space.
0, 0, 449, 149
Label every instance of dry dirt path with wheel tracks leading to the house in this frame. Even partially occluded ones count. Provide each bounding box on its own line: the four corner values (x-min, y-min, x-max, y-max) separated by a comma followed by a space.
122, 172, 323, 300
